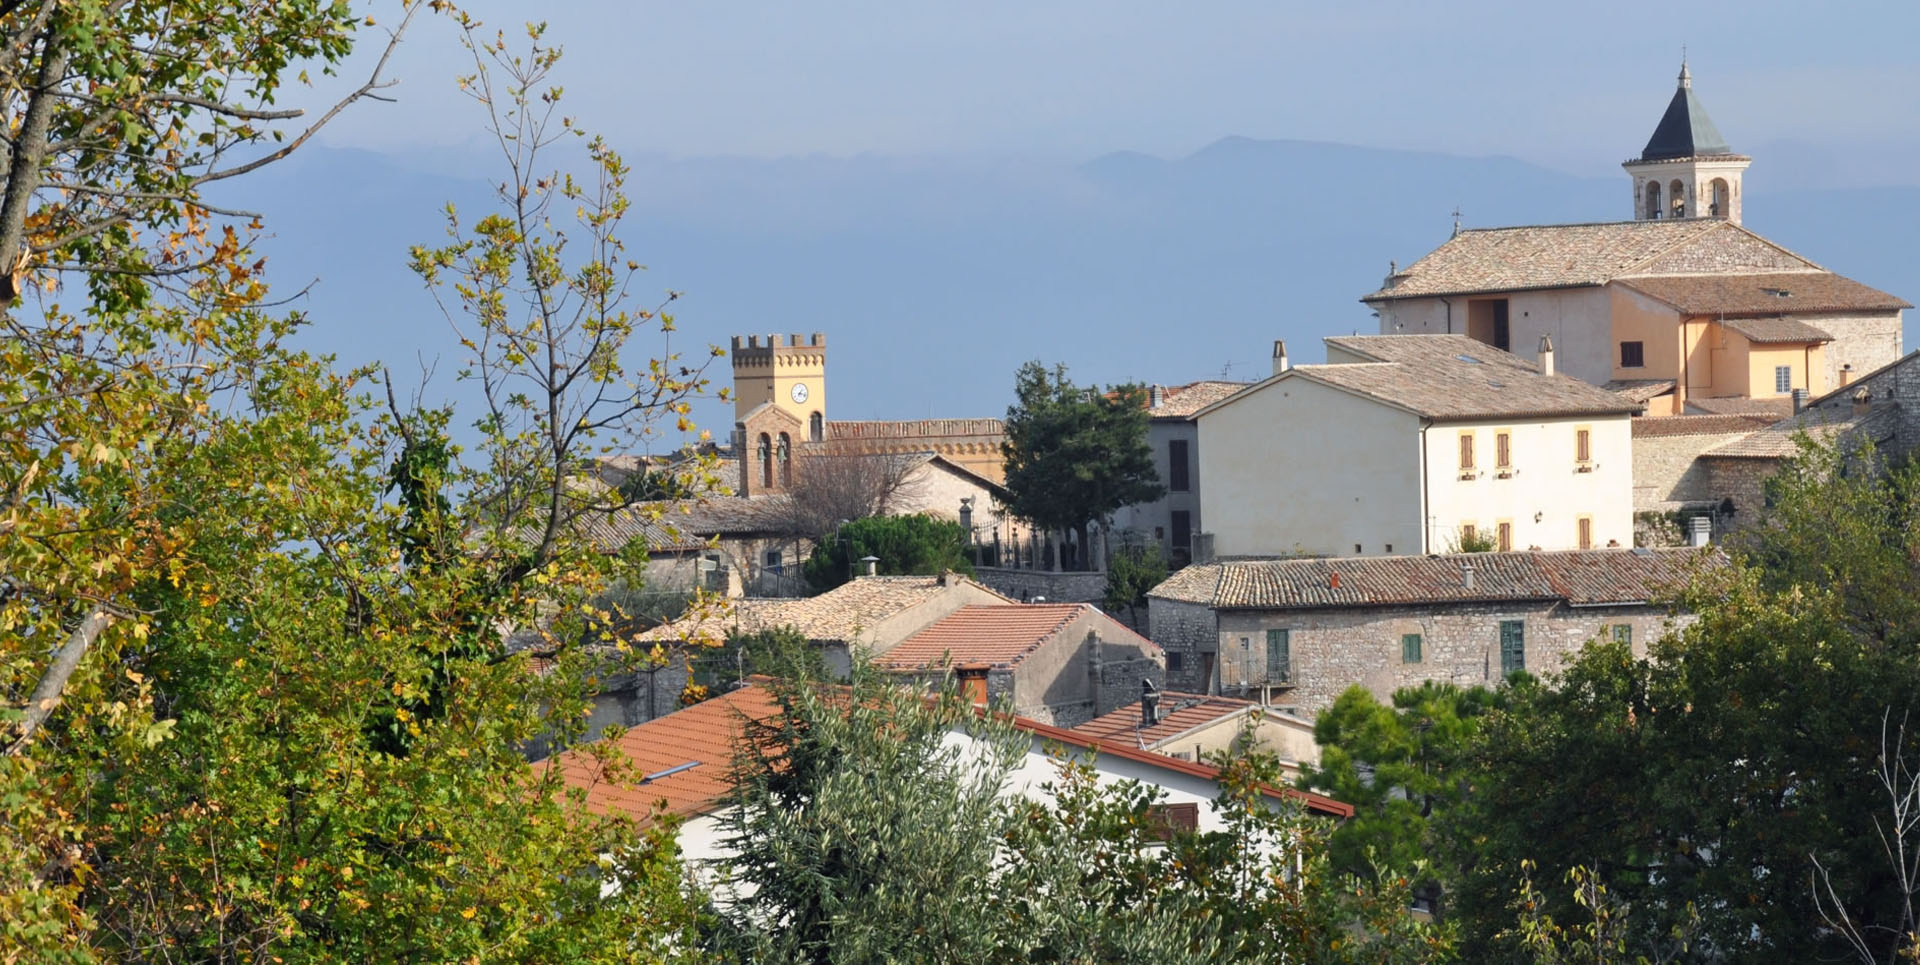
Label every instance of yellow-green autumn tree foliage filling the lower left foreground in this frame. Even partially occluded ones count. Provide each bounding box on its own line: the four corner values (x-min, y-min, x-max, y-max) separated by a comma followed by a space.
0, 15, 714, 961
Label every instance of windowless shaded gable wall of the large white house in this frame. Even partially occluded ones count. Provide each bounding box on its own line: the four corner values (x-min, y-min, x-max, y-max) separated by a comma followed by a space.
1198, 370, 1423, 556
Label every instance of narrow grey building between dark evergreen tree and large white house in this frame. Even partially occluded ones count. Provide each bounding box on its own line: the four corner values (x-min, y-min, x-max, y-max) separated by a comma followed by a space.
1114, 374, 1244, 566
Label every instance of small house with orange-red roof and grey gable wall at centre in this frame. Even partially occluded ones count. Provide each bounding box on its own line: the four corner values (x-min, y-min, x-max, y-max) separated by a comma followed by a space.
874, 602, 1165, 727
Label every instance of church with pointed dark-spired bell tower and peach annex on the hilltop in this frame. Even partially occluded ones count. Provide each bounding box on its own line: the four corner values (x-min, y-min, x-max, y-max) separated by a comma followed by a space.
1361, 63, 1912, 414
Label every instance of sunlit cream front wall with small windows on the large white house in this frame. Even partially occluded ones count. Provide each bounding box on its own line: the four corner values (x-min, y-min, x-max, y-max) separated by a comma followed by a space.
1428, 414, 1634, 553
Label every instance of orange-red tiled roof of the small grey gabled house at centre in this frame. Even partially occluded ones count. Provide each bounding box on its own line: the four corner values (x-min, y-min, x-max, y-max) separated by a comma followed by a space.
877, 602, 1158, 670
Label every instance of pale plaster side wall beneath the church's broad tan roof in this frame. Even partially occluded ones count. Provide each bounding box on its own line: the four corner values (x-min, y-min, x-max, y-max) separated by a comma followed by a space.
1367, 288, 1613, 386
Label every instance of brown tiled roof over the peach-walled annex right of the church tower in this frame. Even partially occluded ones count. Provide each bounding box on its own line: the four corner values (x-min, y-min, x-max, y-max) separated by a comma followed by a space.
1619, 271, 1912, 317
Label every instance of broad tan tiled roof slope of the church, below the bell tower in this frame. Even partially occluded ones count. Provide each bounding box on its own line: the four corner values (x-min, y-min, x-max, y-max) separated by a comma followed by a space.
1361, 219, 1734, 301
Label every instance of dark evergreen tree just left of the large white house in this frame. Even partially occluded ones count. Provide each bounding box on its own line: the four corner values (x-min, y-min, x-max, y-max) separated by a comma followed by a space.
1000, 361, 1165, 570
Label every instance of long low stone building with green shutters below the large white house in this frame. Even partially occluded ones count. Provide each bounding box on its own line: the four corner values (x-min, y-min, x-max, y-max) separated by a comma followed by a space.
1148, 549, 1718, 718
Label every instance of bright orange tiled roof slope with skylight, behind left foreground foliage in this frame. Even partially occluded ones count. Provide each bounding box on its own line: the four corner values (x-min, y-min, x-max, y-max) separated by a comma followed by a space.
545, 687, 776, 817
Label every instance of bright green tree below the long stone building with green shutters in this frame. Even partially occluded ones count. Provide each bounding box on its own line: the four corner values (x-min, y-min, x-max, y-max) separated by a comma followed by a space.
1300, 681, 1500, 917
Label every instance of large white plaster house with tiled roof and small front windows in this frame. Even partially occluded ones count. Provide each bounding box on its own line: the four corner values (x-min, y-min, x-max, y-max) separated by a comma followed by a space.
1196, 336, 1640, 556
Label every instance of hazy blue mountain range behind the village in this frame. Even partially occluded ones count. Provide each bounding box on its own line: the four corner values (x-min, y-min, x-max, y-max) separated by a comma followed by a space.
223, 138, 1920, 435
